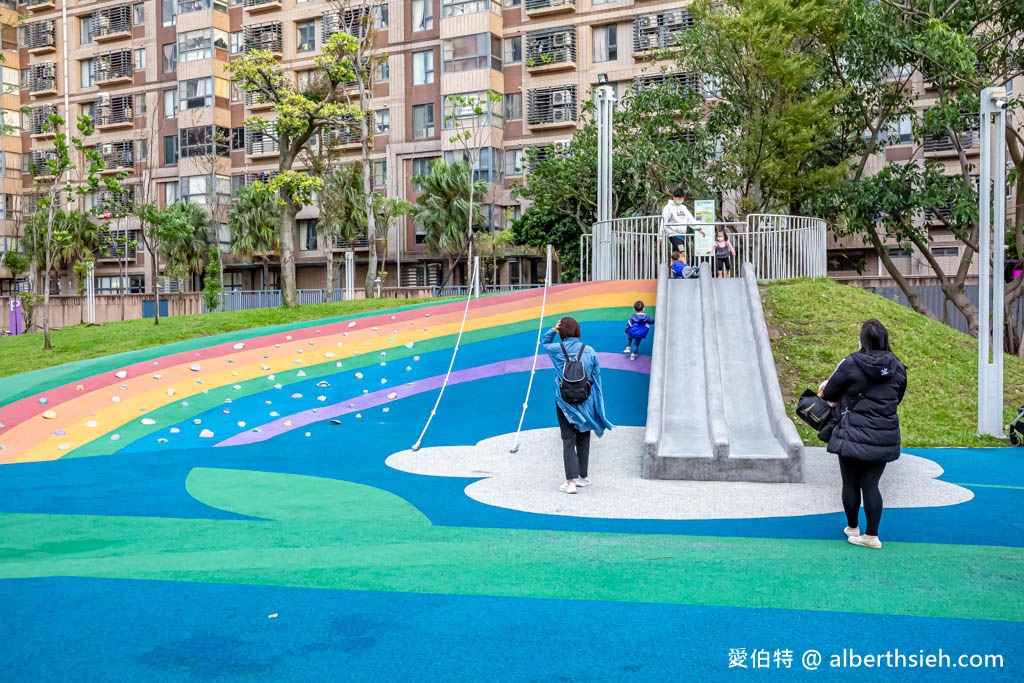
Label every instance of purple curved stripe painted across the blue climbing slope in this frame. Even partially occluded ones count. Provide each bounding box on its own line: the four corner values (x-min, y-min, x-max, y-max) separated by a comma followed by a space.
215, 353, 650, 447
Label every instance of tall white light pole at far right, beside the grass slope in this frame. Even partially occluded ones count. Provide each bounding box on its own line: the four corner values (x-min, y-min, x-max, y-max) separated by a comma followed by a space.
978, 88, 1008, 436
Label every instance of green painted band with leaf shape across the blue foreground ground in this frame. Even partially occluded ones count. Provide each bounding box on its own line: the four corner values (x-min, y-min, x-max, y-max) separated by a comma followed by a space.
0, 468, 1024, 622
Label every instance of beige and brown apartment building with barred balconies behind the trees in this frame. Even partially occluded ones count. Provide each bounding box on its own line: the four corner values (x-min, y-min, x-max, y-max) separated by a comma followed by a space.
0, 0, 689, 294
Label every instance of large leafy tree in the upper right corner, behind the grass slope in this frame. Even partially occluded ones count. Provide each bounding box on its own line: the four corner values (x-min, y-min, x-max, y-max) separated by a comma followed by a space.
822, 0, 1024, 339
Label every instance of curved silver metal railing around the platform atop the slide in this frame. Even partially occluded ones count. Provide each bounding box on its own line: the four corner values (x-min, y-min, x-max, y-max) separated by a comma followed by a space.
580, 214, 827, 281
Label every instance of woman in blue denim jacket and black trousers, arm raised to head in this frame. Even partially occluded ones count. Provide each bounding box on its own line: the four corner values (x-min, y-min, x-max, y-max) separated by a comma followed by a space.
543, 316, 614, 494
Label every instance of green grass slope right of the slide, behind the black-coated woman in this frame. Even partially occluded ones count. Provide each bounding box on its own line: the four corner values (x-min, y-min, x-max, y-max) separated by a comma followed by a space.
763, 280, 1024, 446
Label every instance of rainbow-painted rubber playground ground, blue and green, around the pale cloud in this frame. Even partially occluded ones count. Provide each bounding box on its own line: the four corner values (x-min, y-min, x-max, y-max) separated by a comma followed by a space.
0, 282, 1024, 681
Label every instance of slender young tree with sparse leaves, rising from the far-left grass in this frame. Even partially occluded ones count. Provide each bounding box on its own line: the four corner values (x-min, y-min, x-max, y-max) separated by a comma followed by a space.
32, 114, 127, 350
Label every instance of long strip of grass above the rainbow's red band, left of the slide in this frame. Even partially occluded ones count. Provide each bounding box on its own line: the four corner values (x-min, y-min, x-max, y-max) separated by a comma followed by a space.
0, 299, 433, 377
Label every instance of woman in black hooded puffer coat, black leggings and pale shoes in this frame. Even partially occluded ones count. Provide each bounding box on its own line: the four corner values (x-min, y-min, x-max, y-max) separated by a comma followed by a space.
818, 319, 906, 548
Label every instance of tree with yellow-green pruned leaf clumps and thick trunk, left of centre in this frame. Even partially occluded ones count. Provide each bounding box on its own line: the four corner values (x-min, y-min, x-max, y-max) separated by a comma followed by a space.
227, 33, 359, 308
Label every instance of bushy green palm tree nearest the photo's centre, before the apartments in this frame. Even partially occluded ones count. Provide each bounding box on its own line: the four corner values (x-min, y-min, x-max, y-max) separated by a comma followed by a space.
413, 159, 487, 282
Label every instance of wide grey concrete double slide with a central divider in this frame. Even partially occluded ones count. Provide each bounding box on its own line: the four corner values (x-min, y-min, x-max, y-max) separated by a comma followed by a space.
643, 267, 804, 482
